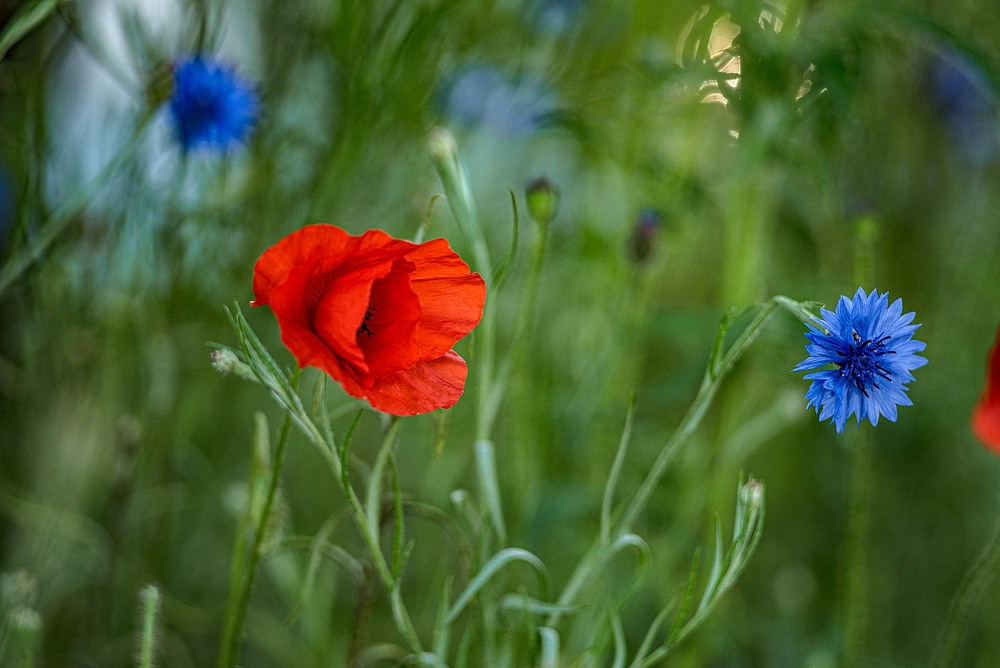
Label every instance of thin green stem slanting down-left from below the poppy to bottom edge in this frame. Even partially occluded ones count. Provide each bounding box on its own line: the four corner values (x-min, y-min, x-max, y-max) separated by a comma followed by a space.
218, 376, 299, 668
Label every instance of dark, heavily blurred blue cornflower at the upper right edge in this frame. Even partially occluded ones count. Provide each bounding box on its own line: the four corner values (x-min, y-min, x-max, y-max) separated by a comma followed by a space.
928, 54, 1000, 164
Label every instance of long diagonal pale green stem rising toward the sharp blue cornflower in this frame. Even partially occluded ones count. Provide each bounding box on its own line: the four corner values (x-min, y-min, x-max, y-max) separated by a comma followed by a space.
545, 298, 783, 628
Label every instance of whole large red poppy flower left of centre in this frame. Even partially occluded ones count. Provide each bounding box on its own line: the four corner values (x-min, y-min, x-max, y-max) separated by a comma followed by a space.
251, 225, 486, 415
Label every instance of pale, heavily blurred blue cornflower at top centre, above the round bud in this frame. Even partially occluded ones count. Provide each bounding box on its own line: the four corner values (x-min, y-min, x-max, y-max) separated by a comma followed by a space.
443, 65, 556, 136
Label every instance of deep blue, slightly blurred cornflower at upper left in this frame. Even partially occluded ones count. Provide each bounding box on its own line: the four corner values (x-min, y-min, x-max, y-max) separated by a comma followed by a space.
170, 56, 259, 150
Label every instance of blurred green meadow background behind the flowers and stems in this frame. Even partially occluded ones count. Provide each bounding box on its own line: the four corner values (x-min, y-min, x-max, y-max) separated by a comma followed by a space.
0, 0, 1000, 667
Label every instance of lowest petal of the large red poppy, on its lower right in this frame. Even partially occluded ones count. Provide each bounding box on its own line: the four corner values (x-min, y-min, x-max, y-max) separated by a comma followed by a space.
362, 350, 469, 415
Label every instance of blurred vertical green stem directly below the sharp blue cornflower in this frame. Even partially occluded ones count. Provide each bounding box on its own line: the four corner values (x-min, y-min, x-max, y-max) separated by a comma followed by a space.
841, 422, 872, 666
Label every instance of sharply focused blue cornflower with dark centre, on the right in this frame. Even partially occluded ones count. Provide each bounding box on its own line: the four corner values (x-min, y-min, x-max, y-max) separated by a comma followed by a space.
793, 288, 927, 433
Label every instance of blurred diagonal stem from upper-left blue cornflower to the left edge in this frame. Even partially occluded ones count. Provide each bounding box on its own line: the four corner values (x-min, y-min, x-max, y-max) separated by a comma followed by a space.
0, 110, 152, 298
